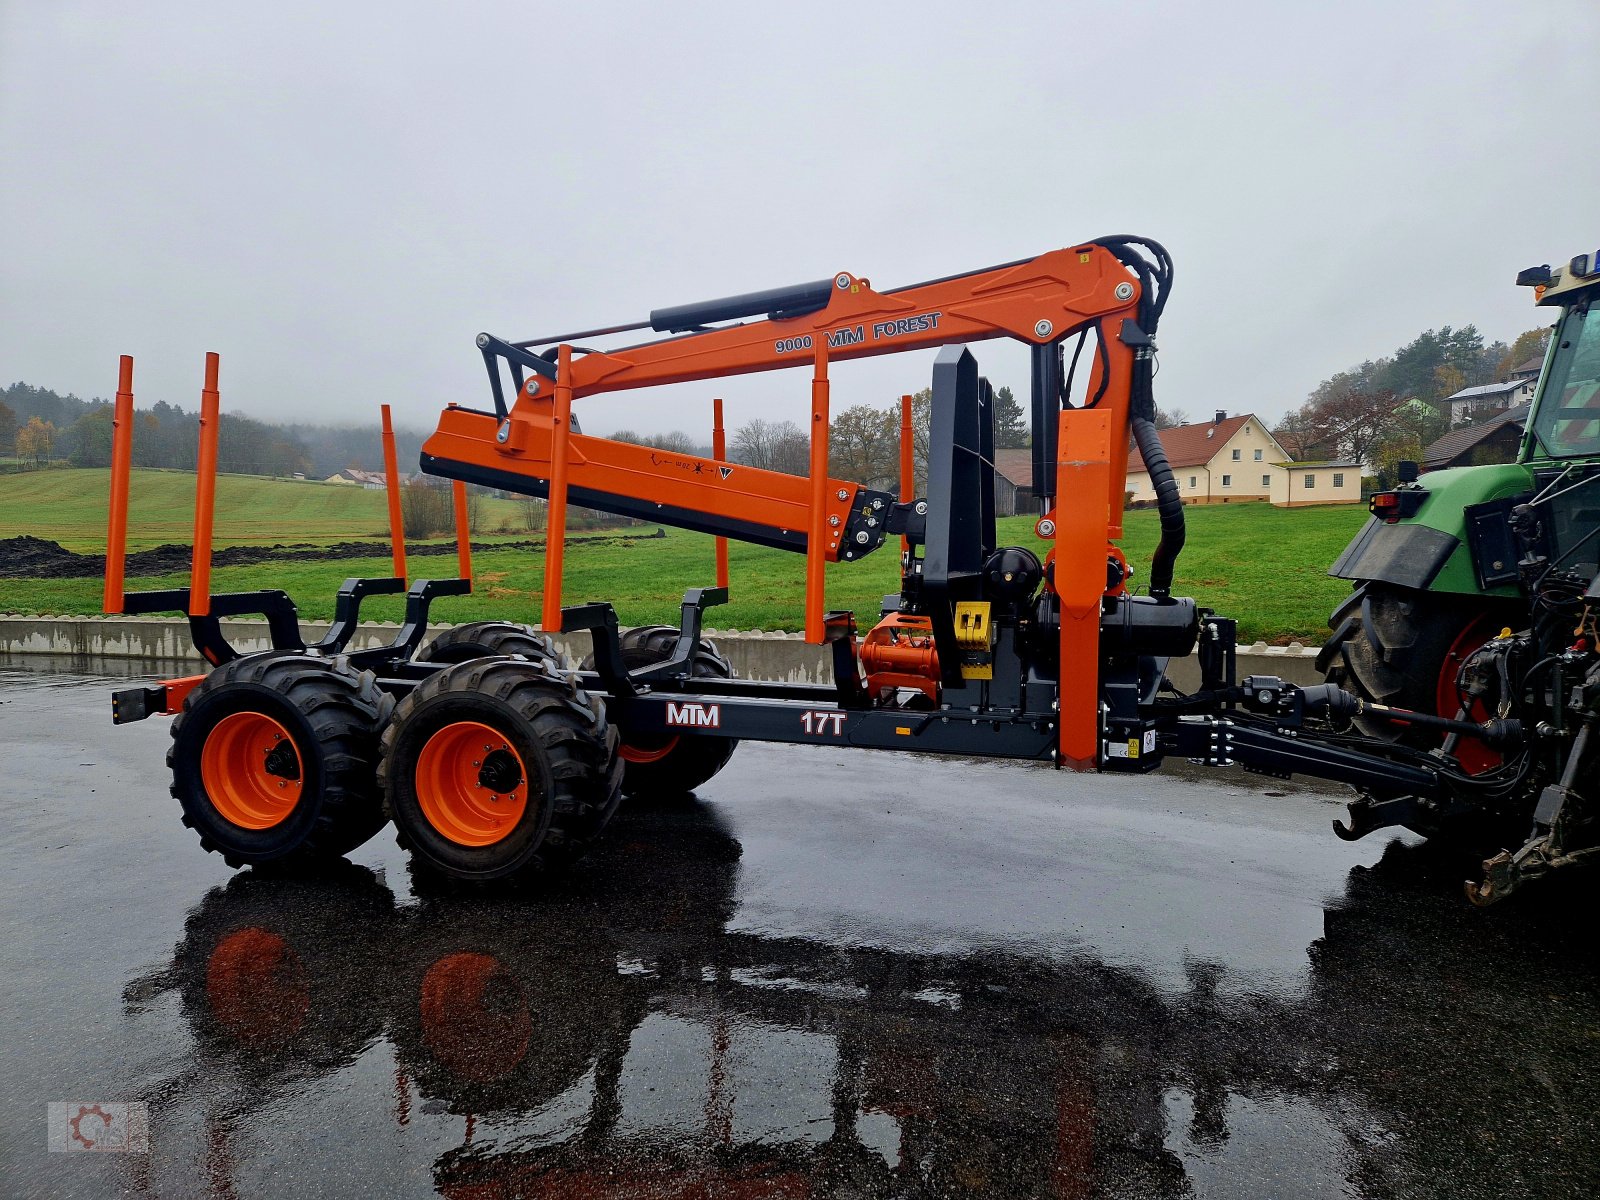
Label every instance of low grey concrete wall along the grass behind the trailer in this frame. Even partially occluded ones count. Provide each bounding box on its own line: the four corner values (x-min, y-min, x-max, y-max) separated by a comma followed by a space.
0, 614, 1322, 690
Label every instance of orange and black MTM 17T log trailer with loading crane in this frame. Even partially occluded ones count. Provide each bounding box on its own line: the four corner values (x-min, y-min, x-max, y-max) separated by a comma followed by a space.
106, 237, 1600, 902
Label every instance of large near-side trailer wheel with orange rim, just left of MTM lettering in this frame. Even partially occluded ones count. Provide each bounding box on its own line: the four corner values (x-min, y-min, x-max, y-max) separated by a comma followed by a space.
378, 658, 622, 883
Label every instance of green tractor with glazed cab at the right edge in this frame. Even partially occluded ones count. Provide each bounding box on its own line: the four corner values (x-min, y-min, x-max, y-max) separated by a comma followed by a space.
1317, 254, 1600, 773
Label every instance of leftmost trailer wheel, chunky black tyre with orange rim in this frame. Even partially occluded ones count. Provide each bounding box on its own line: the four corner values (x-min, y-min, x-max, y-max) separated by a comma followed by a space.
166, 651, 394, 867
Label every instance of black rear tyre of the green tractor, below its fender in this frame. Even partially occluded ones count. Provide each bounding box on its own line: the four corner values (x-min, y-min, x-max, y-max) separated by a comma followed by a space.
1318, 582, 1525, 774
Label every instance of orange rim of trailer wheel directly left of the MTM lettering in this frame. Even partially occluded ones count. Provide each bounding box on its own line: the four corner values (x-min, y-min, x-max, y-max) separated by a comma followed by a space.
416, 722, 528, 846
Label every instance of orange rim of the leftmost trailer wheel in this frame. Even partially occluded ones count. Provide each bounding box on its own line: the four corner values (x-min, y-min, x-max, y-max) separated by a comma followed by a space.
200, 712, 304, 829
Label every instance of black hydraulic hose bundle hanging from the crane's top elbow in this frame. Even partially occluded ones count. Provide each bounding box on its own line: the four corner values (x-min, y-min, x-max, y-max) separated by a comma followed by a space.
1098, 235, 1187, 600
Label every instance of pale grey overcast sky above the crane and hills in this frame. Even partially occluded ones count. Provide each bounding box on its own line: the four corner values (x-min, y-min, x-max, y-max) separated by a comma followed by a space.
0, 0, 1600, 434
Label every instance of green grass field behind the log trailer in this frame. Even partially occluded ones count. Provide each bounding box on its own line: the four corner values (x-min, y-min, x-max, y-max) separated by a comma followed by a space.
0, 470, 1366, 643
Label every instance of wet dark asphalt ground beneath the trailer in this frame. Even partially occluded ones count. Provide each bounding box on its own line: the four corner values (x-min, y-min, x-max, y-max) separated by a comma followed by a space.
0, 659, 1600, 1200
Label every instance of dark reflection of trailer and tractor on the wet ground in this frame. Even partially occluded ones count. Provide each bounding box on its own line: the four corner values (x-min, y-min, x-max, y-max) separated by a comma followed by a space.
93, 784, 1594, 1200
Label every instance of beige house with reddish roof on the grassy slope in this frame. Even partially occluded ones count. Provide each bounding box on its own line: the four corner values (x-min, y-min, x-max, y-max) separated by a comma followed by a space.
1128, 411, 1292, 504
